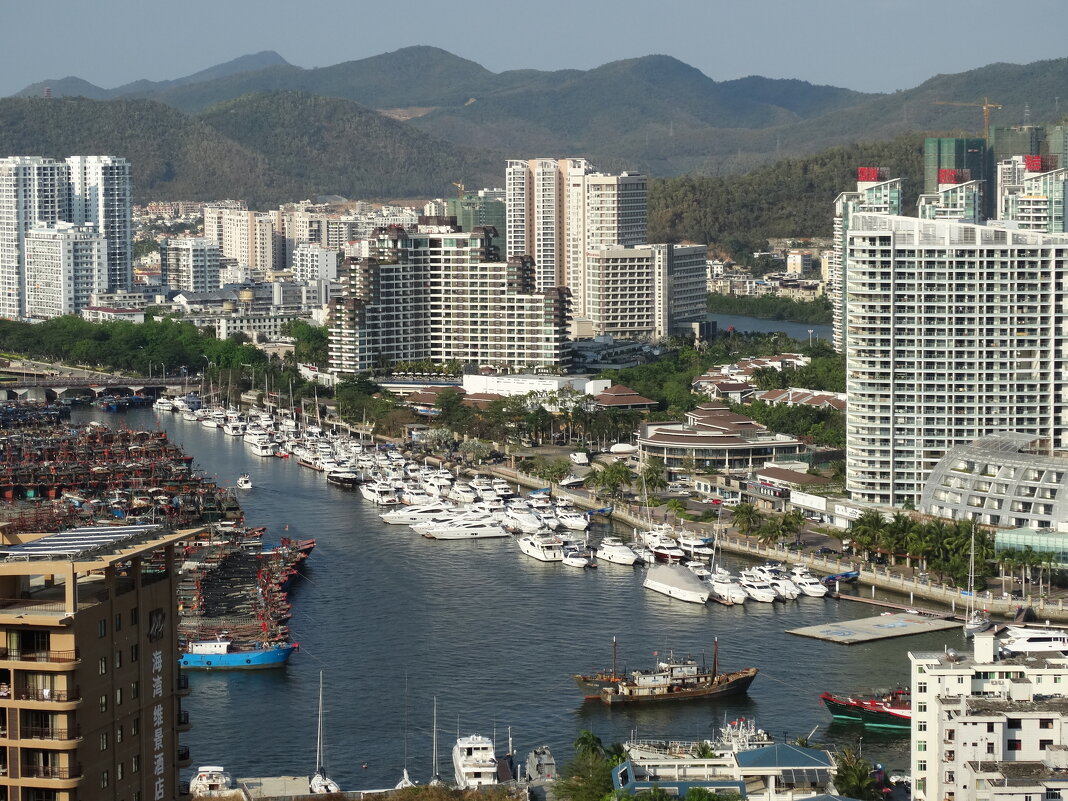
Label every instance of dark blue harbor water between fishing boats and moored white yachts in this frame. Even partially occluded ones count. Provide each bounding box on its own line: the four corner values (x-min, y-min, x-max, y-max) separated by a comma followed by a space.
75, 409, 944, 789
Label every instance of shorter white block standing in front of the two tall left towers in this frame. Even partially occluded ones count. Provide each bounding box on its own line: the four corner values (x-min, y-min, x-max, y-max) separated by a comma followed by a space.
26, 222, 108, 319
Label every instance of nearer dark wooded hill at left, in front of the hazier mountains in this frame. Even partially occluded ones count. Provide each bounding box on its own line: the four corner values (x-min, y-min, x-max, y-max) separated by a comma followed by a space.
0, 92, 504, 207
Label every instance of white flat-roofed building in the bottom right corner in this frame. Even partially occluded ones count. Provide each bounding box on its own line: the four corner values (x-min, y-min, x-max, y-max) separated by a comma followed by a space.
909, 645, 1068, 801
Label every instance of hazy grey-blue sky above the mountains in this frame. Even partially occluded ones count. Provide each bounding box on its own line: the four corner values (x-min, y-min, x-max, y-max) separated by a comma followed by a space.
0, 0, 1068, 96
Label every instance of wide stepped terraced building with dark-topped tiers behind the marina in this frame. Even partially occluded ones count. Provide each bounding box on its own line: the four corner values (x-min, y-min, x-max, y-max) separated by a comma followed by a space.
329, 220, 567, 373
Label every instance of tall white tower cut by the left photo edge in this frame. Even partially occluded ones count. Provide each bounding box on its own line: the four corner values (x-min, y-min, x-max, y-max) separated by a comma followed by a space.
0, 156, 70, 318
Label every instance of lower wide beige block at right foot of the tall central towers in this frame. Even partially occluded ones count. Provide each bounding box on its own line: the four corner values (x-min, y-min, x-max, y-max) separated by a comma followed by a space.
576, 245, 708, 340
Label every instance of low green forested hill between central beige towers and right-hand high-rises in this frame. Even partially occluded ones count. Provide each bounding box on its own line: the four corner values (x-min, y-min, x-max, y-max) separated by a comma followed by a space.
649, 135, 924, 249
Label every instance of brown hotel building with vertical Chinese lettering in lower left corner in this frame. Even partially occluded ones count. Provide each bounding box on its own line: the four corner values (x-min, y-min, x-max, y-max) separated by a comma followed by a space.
0, 525, 190, 801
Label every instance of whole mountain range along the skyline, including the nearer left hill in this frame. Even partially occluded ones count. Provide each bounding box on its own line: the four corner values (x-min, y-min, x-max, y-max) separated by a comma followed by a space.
8, 46, 1068, 203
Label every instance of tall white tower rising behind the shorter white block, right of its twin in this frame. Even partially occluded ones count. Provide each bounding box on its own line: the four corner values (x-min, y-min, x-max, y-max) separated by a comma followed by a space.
67, 156, 134, 292
